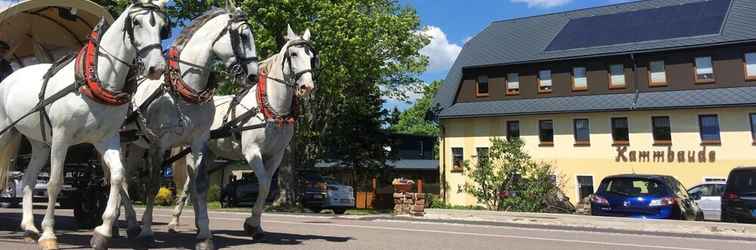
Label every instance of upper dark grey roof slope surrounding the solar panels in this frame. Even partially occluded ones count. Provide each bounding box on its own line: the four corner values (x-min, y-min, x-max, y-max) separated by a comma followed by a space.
434, 0, 756, 108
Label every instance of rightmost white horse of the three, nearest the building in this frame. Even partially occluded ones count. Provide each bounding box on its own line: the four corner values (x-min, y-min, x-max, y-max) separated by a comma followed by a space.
168, 27, 317, 239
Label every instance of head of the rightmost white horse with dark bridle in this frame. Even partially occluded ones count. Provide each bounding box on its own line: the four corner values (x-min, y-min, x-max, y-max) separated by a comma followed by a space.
280, 26, 320, 96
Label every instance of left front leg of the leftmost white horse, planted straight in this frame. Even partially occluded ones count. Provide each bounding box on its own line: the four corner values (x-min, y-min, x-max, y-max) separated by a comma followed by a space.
38, 138, 70, 250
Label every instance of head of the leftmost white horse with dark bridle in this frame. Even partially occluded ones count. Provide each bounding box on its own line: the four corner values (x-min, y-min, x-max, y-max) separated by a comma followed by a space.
122, 0, 171, 79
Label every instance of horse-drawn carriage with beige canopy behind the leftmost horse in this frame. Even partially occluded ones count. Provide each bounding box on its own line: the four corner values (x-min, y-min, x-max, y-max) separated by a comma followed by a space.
0, 0, 113, 228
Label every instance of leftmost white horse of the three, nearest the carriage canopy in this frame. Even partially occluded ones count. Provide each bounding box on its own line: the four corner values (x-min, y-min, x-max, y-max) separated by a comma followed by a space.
0, 0, 170, 249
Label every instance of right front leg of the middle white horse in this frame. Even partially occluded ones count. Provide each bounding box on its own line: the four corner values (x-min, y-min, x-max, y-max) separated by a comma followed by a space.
191, 140, 214, 250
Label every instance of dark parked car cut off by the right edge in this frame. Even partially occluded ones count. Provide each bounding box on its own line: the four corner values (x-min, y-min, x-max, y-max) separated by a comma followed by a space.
722, 167, 756, 223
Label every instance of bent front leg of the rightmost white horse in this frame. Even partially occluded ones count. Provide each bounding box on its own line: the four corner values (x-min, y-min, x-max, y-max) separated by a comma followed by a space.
244, 147, 283, 240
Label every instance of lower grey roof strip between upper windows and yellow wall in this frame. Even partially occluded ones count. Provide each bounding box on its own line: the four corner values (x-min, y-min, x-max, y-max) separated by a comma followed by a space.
439, 87, 756, 118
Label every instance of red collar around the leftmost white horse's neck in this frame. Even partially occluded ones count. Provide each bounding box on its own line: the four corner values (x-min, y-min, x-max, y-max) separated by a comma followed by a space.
74, 19, 139, 106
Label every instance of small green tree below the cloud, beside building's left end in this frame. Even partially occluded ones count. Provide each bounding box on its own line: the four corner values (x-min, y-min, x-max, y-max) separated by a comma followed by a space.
391, 80, 443, 136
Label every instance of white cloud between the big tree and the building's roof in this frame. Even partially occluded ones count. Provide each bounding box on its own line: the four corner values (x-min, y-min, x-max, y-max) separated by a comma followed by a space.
420, 26, 462, 72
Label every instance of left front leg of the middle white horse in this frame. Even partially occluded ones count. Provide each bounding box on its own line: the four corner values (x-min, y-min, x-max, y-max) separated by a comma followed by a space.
137, 147, 163, 247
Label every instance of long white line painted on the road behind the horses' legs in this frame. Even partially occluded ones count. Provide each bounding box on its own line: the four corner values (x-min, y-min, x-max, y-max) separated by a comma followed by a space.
149, 215, 710, 250
